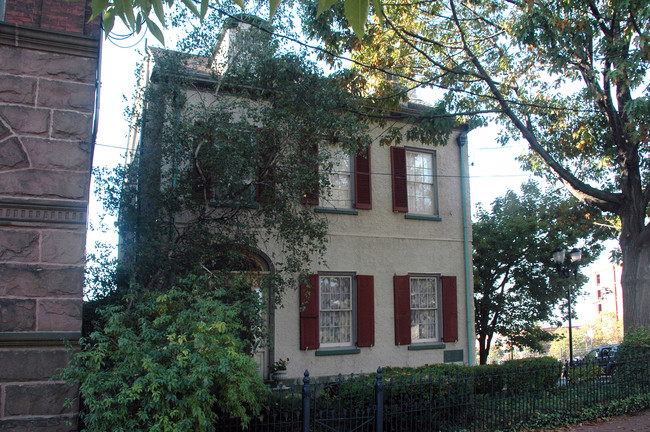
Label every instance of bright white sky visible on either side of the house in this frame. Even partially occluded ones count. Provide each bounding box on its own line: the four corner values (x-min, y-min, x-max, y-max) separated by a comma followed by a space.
87, 23, 611, 325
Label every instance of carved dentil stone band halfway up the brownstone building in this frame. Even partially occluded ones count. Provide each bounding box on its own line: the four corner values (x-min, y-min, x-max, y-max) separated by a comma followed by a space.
0, 198, 88, 226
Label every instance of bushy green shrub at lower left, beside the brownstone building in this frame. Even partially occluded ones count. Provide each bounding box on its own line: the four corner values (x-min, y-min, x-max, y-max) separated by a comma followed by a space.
60, 277, 266, 432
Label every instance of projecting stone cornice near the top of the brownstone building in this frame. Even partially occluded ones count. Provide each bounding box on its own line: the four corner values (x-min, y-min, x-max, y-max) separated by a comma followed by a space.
0, 22, 99, 58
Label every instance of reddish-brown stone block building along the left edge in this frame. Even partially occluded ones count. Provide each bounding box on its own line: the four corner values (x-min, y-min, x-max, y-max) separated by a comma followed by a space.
0, 0, 101, 431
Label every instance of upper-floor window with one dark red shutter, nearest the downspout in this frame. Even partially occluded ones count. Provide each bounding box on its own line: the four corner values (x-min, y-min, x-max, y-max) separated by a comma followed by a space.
391, 147, 438, 217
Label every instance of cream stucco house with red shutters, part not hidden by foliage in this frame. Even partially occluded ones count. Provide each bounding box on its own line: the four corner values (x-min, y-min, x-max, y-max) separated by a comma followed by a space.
129, 16, 475, 379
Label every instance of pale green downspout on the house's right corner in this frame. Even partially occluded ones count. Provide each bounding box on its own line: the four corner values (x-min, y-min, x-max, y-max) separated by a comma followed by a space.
456, 127, 474, 366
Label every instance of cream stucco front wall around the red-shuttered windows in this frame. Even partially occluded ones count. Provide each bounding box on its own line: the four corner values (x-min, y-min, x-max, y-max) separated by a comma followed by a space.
271, 130, 474, 378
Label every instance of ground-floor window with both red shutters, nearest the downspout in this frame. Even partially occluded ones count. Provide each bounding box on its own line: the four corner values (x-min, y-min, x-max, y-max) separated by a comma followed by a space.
393, 275, 458, 345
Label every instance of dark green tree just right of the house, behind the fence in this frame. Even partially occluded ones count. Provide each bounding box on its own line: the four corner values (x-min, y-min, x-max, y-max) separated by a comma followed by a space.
473, 182, 603, 364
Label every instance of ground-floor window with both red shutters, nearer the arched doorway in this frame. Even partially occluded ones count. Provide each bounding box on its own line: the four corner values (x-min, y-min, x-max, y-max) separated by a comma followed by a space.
300, 273, 375, 350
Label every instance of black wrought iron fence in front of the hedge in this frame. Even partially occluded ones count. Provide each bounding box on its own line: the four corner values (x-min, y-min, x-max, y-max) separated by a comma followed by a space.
218, 357, 650, 432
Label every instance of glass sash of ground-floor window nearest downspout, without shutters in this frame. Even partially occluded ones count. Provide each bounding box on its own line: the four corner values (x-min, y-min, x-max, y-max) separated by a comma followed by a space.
410, 277, 439, 341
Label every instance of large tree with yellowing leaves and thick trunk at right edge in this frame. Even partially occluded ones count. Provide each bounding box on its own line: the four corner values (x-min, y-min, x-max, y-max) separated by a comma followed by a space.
305, 0, 650, 328
